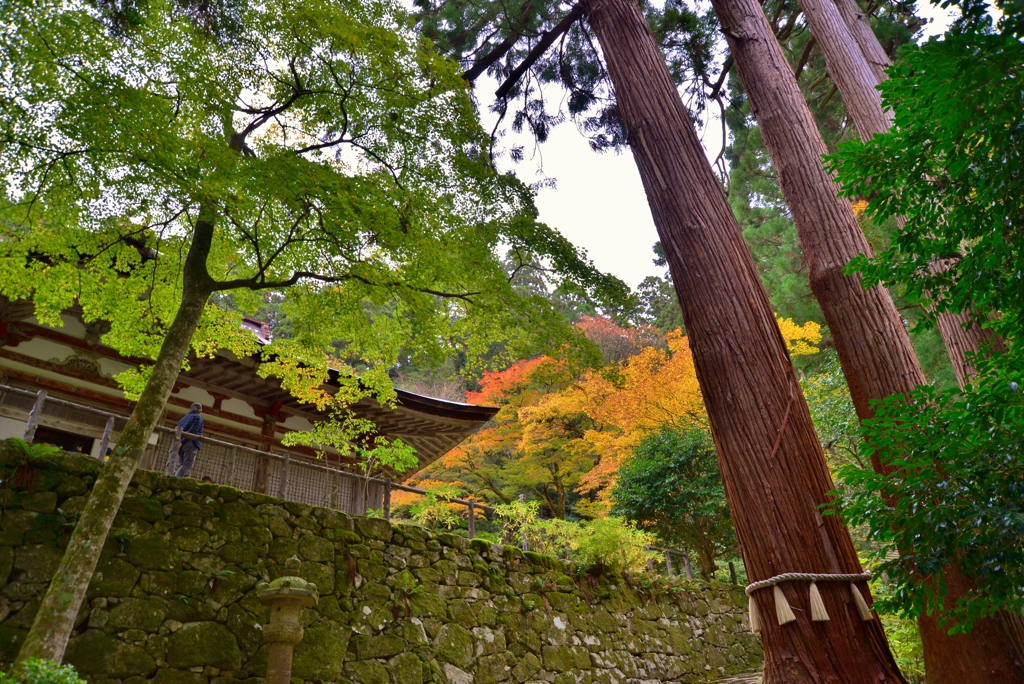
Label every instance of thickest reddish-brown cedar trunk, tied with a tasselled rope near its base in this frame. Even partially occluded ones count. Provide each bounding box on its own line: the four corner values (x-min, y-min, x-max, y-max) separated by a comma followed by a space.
589, 0, 904, 684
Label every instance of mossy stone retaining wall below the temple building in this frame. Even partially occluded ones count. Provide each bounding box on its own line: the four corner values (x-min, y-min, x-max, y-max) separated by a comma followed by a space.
0, 444, 761, 684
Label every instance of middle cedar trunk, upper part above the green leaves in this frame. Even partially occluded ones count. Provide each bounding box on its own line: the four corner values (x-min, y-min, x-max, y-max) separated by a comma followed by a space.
712, 0, 925, 432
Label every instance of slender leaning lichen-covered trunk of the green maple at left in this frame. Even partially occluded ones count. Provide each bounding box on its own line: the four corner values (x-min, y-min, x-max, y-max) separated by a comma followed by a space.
17, 212, 214, 662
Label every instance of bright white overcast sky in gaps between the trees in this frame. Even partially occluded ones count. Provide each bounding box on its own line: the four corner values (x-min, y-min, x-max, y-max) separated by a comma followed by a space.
477, 2, 950, 288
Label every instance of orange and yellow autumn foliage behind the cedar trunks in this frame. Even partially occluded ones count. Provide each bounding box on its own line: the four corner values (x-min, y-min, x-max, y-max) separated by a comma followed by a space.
403, 317, 821, 517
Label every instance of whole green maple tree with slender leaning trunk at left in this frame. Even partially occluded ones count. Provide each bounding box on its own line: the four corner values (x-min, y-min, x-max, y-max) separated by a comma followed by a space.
0, 0, 625, 660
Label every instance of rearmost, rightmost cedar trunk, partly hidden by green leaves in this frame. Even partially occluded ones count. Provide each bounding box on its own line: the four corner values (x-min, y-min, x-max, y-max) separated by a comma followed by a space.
800, 0, 1001, 387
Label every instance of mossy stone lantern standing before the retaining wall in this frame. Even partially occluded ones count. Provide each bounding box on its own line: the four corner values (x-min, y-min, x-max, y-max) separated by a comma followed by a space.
256, 557, 318, 684
